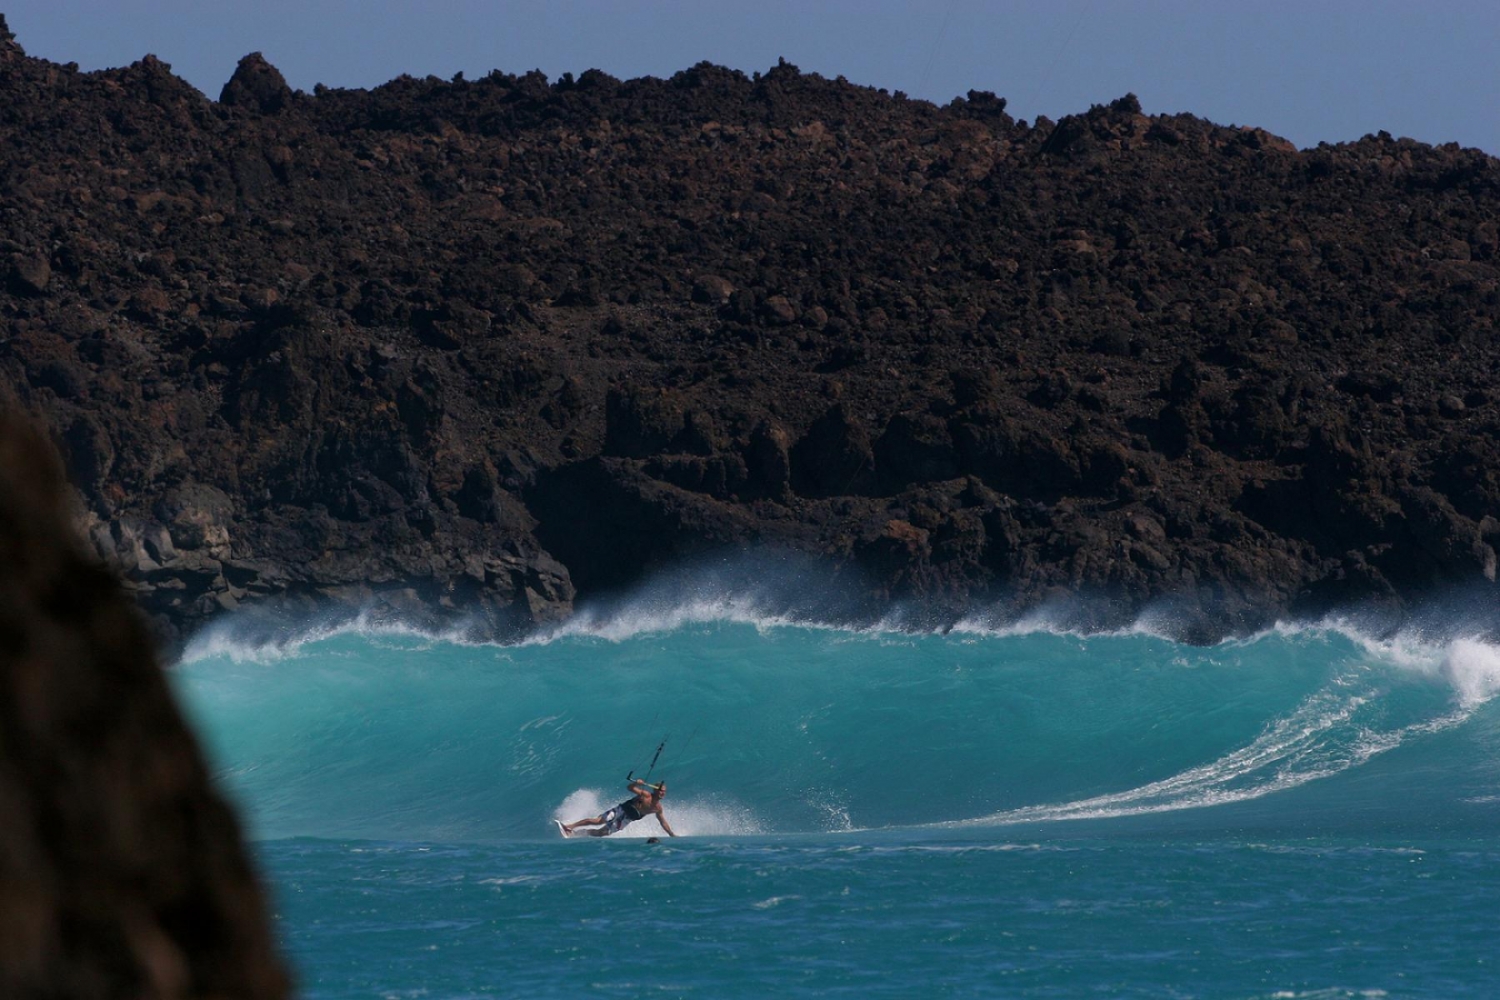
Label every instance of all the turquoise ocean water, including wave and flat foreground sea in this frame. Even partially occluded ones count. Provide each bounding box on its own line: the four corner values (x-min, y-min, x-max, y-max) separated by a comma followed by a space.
171, 603, 1500, 1000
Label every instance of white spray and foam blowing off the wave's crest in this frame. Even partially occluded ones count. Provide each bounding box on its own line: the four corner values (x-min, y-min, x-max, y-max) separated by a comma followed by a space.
180, 553, 1500, 659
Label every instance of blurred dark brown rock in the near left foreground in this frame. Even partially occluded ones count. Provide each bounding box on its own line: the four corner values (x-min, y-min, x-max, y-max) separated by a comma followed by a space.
0, 414, 288, 1000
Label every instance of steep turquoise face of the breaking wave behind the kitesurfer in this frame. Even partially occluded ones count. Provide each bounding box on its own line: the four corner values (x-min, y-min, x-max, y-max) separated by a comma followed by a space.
173, 606, 1500, 843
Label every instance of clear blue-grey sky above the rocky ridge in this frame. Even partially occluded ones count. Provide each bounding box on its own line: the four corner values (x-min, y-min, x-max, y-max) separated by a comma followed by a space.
0, 0, 1500, 154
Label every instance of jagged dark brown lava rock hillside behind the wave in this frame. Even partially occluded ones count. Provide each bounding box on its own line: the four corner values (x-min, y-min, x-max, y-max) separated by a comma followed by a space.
0, 27, 1500, 644
